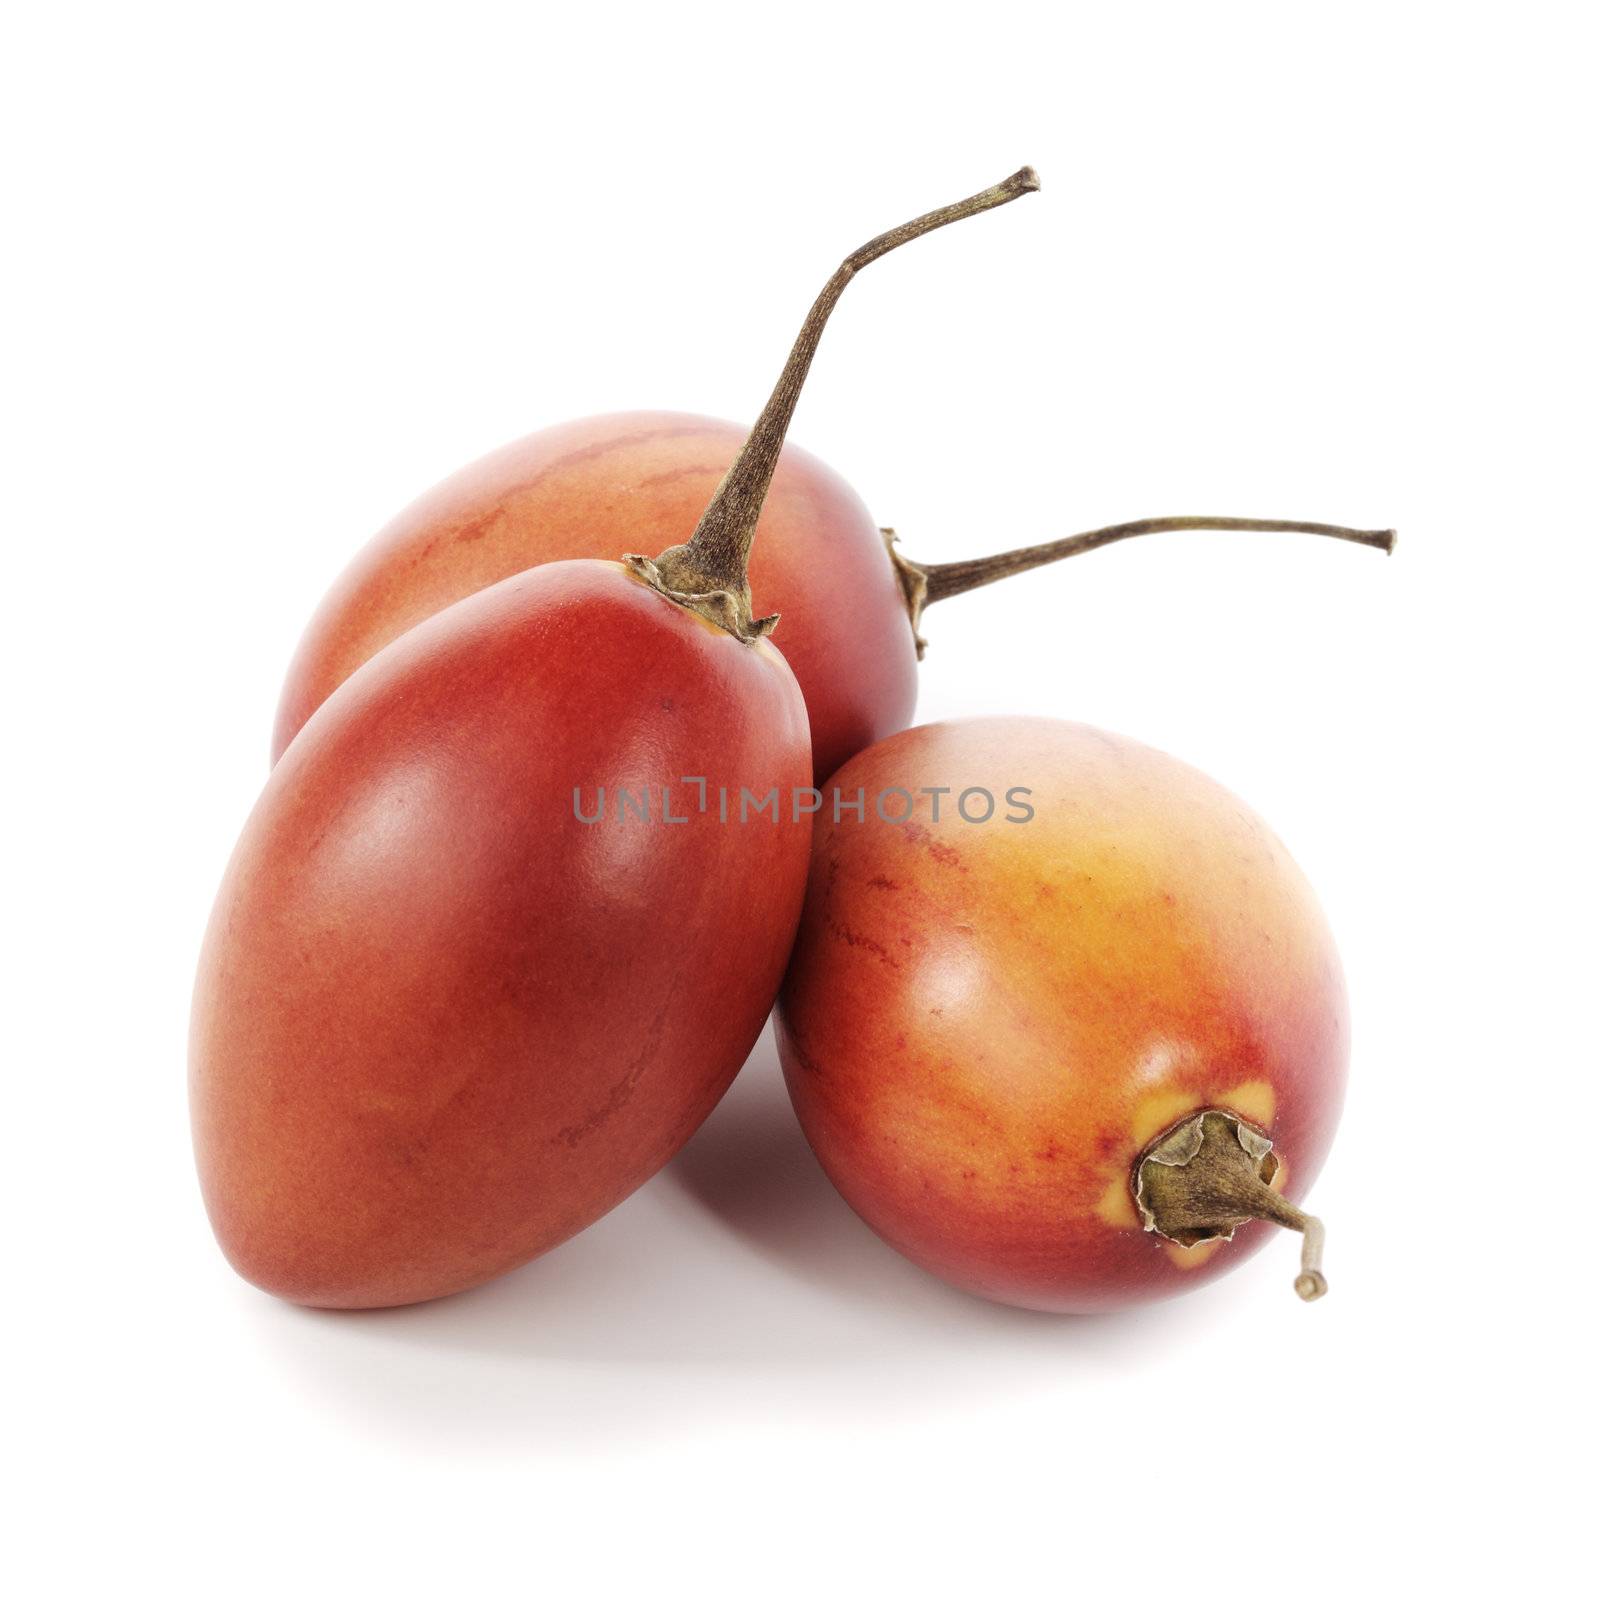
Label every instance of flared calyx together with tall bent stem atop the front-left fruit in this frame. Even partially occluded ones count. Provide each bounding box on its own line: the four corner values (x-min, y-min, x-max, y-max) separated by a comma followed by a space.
622, 166, 1038, 643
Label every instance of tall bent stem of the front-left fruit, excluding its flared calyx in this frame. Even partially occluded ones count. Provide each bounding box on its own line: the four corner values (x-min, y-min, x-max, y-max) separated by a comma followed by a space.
675, 166, 1038, 624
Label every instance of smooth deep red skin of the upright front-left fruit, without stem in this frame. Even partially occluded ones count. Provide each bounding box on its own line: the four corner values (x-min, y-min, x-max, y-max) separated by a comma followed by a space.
190, 562, 811, 1307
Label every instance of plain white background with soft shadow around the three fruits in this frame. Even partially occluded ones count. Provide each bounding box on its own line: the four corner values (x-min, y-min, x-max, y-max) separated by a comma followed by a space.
0, 0, 1600, 1595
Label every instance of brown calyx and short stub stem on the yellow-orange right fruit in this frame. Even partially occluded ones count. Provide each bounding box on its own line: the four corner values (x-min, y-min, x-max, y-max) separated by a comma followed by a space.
1133, 1109, 1328, 1301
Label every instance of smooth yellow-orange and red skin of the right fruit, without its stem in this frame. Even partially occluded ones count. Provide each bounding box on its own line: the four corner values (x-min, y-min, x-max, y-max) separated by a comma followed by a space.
778, 718, 1349, 1312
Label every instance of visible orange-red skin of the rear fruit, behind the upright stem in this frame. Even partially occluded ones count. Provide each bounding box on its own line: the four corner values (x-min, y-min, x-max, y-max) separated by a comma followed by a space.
272, 411, 917, 782
